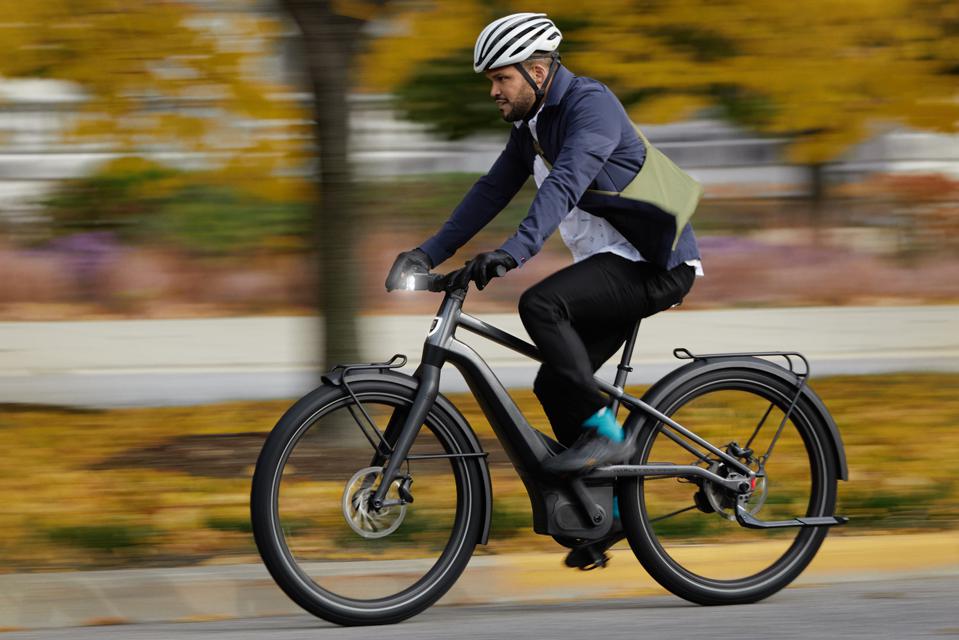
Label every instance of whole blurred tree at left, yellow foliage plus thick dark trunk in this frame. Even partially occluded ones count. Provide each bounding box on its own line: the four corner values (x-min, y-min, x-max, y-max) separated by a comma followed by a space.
0, 0, 376, 363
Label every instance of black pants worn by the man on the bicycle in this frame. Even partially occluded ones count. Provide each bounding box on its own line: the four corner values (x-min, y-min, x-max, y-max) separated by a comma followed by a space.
519, 253, 696, 446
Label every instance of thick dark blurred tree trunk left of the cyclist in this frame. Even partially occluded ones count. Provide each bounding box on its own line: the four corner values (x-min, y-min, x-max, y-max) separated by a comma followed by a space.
282, 0, 363, 370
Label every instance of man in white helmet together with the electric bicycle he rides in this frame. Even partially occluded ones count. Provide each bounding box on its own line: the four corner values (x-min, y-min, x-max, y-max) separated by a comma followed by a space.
250, 13, 848, 600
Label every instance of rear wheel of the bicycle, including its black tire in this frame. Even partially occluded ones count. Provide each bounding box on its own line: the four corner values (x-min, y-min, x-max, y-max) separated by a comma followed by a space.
618, 369, 836, 605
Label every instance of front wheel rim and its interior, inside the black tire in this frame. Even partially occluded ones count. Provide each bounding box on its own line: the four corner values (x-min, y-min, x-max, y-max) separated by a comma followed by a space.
264, 392, 471, 610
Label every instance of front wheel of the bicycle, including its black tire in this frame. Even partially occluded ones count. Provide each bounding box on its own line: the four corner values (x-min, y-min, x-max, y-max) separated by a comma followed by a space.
250, 379, 485, 625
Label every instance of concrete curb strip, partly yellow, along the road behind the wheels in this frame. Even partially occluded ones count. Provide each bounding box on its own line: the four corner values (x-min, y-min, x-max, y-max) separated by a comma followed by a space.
0, 532, 959, 631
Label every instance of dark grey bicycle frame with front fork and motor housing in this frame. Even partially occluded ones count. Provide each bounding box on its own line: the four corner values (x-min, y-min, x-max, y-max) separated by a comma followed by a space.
371, 290, 756, 537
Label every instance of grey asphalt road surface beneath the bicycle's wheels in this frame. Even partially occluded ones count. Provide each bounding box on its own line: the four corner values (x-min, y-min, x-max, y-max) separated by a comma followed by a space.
3, 576, 959, 640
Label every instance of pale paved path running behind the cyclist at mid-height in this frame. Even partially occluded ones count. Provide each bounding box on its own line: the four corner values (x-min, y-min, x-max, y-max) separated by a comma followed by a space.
0, 306, 959, 406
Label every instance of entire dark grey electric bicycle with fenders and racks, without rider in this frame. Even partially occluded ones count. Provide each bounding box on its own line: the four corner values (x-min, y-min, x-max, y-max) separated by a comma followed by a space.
250, 284, 847, 625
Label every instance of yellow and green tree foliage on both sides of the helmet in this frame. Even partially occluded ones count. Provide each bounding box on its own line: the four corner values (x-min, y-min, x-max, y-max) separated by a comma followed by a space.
363, 0, 959, 224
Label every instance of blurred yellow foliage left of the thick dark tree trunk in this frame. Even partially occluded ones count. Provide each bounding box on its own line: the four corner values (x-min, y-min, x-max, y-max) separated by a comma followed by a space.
0, 0, 305, 199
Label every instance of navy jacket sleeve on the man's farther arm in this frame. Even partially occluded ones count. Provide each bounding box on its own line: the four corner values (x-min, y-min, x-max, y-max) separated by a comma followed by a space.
419, 127, 530, 267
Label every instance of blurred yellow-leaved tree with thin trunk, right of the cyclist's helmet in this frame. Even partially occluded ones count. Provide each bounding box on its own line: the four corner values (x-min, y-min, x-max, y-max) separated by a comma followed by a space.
568, 0, 959, 227
